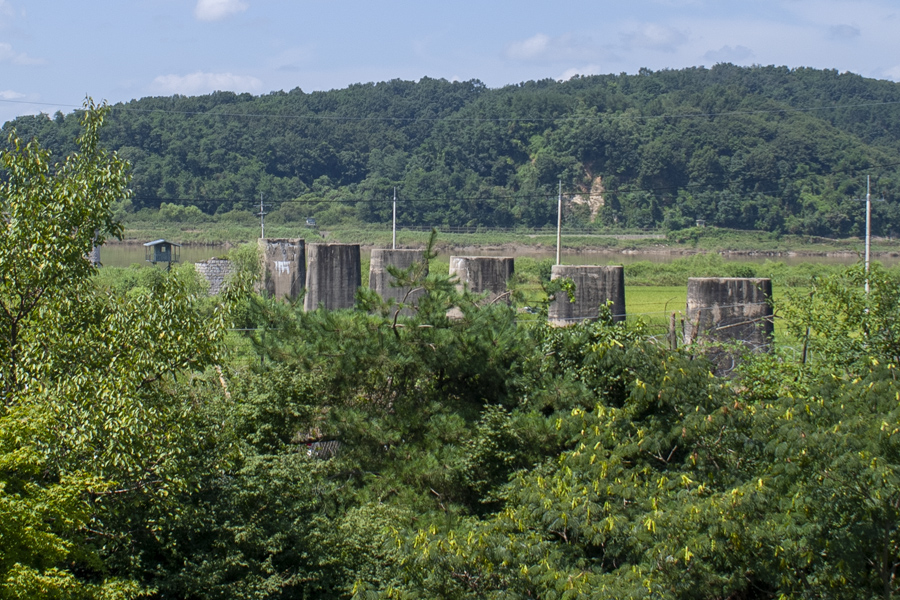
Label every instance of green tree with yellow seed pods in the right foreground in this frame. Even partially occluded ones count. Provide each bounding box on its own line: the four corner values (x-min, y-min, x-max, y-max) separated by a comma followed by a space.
374, 271, 900, 599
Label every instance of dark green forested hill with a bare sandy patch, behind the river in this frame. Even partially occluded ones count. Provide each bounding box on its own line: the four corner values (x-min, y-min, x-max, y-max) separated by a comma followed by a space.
3, 64, 900, 236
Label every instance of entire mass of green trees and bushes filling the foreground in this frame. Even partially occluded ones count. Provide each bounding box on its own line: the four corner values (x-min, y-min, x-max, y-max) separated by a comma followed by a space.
0, 107, 900, 600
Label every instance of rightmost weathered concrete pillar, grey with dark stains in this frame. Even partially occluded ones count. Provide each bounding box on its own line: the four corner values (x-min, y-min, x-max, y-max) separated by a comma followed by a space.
684, 277, 775, 372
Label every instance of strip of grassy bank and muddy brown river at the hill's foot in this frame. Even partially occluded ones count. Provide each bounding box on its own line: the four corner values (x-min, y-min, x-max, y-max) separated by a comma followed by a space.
111, 220, 900, 263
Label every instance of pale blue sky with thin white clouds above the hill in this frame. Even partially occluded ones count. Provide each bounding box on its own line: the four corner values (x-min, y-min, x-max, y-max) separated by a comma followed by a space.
0, 0, 900, 122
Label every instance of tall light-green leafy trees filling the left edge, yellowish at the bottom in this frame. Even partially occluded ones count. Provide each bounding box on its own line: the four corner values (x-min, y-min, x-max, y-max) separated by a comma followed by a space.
0, 102, 229, 598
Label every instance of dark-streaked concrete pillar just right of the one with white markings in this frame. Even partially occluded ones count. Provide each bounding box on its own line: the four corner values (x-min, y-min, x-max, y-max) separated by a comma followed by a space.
303, 244, 361, 310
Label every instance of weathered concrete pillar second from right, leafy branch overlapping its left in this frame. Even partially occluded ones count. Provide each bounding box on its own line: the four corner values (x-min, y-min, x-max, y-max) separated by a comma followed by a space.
548, 265, 625, 325
